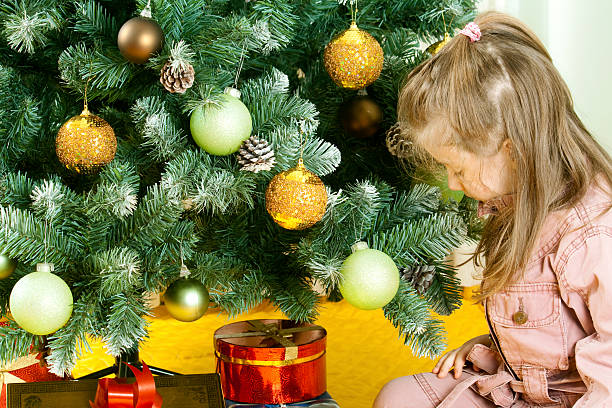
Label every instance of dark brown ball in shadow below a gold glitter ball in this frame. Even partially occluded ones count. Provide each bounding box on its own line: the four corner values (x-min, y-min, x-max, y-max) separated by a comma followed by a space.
340, 93, 382, 139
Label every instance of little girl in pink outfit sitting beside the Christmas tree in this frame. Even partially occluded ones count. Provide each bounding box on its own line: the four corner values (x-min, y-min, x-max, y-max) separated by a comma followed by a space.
374, 13, 612, 408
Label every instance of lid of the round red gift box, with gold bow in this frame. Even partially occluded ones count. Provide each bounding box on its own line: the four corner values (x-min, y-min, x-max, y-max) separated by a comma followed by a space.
214, 319, 327, 365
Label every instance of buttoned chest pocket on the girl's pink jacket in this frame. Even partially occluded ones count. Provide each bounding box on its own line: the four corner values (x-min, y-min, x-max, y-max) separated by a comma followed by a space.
487, 283, 569, 372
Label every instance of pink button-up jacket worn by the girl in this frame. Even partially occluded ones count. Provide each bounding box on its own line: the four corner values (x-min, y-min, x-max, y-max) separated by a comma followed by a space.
440, 179, 612, 408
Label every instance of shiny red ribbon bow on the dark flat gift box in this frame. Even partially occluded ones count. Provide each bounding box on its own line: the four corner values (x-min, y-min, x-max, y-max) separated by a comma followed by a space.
89, 361, 162, 408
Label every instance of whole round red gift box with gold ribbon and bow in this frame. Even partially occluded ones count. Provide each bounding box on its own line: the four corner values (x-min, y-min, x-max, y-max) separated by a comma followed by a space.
215, 319, 327, 404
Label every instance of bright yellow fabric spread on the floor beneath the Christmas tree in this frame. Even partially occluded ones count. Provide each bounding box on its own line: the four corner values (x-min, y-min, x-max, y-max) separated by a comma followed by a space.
73, 290, 488, 408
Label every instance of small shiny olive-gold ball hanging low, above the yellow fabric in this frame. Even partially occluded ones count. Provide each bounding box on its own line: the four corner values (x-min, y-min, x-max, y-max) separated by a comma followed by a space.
164, 264, 210, 322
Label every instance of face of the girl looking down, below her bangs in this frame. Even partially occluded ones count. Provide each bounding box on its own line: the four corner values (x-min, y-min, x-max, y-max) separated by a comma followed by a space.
423, 139, 516, 201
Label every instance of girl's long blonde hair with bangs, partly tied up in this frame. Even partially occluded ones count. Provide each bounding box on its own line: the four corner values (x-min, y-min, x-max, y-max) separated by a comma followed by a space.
398, 12, 612, 300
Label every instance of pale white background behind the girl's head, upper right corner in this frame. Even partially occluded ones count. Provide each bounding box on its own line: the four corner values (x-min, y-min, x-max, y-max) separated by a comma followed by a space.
479, 0, 612, 154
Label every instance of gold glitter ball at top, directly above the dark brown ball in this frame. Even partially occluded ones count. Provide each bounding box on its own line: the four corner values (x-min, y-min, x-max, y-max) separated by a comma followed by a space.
323, 22, 384, 89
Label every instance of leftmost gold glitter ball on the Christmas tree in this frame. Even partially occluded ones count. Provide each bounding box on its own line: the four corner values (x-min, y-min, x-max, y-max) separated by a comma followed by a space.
55, 108, 117, 174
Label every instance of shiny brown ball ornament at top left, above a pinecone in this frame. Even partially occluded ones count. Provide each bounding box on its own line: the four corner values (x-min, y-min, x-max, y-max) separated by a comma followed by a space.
117, 0, 164, 64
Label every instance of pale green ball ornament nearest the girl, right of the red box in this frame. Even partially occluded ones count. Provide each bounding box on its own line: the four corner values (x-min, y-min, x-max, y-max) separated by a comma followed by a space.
340, 242, 399, 310
